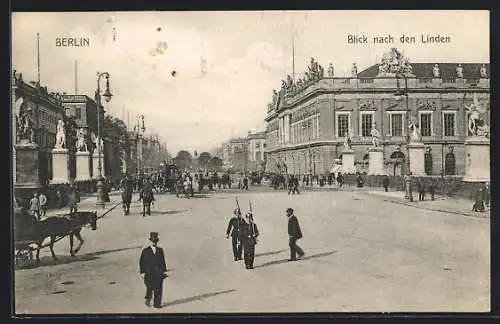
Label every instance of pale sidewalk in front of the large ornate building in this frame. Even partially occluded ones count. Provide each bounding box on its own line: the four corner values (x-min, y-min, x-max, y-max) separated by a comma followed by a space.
365, 189, 490, 218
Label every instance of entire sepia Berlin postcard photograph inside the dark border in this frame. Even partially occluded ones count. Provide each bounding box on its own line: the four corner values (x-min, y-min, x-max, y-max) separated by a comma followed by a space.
9, 10, 491, 317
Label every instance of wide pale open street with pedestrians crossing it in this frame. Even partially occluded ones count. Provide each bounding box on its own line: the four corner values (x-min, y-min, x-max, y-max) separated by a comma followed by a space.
15, 190, 490, 314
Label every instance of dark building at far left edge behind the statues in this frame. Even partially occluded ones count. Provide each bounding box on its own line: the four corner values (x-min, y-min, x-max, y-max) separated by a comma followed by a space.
12, 71, 64, 184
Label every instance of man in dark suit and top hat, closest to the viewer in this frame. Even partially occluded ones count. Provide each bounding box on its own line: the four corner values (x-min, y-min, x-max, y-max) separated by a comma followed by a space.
139, 232, 167, 308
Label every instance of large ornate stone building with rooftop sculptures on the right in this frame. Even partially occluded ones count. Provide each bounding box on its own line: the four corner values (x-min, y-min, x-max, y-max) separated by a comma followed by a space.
265, 49, 490, 175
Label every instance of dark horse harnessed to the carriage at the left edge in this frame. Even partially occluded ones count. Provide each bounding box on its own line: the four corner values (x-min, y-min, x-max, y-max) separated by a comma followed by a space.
35, 211, 97, 263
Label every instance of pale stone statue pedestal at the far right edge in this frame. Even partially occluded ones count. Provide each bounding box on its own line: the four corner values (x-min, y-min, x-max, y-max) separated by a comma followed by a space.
463, 136, 490, 182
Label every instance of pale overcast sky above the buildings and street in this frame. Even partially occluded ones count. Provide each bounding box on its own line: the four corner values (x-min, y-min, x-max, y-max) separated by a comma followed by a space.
12, 11, 490, 152
